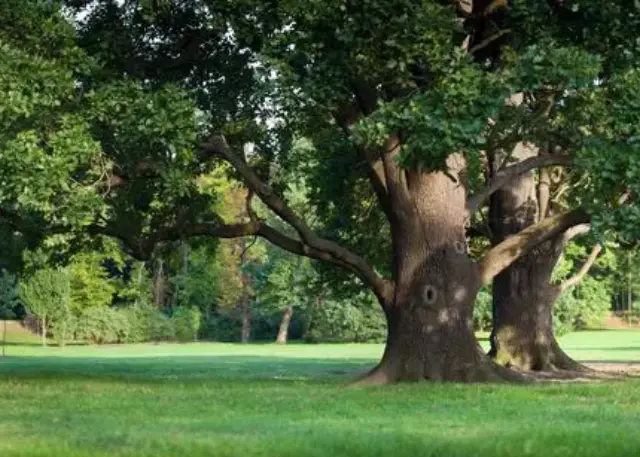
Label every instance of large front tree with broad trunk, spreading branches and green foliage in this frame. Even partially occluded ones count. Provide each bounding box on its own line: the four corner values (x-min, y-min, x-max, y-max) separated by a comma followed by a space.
5, 0, 638, 383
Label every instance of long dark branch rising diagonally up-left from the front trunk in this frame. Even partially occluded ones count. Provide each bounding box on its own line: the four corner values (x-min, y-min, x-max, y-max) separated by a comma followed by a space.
203, 136, 391, 303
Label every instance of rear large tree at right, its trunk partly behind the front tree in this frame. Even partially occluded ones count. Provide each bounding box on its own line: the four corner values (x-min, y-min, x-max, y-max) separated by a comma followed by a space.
487, 2, 640, 370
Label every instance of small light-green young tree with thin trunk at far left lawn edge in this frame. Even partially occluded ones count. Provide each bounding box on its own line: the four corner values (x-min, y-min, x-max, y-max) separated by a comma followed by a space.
20, 268, 71, 346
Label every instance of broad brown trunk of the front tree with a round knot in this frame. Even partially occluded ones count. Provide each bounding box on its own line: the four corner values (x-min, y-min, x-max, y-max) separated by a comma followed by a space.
359, 158, 523, 384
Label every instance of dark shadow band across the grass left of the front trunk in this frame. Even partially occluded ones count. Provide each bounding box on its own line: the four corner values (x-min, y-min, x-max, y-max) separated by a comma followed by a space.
0, 355, 376, 382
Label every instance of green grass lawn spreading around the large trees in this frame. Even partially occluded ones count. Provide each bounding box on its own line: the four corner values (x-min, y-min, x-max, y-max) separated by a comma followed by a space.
0, 331, 640, 457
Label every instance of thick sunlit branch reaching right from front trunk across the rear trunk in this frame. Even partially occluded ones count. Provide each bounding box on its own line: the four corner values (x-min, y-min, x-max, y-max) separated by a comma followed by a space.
480, 210, 589, 284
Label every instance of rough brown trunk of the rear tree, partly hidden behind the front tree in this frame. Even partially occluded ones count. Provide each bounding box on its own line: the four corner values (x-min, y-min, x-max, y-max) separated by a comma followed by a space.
489, 145, 582, 371
